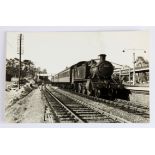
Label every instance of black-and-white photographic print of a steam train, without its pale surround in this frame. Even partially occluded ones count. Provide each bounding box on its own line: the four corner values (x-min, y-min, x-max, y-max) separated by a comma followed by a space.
5, 30, 150, 123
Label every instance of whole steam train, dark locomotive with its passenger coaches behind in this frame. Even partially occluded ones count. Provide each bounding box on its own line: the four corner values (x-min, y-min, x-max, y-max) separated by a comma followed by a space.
51, 54, 129, 99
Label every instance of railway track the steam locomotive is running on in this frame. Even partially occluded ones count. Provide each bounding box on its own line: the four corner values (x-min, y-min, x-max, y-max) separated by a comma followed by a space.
58, 87, 149, 118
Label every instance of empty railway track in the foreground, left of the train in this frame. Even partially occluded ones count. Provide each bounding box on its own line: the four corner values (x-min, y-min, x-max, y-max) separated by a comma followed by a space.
42, 88, 129, 123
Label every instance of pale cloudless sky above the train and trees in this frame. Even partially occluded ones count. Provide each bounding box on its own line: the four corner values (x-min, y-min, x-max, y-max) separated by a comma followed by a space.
6, 31, 150, 74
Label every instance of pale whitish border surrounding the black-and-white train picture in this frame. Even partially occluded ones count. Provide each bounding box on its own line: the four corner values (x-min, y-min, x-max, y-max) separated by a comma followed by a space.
0, 26, 155, 128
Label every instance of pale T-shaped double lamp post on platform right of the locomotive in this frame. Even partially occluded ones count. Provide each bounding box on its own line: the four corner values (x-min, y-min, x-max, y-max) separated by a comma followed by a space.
122, 49, 146, 86
